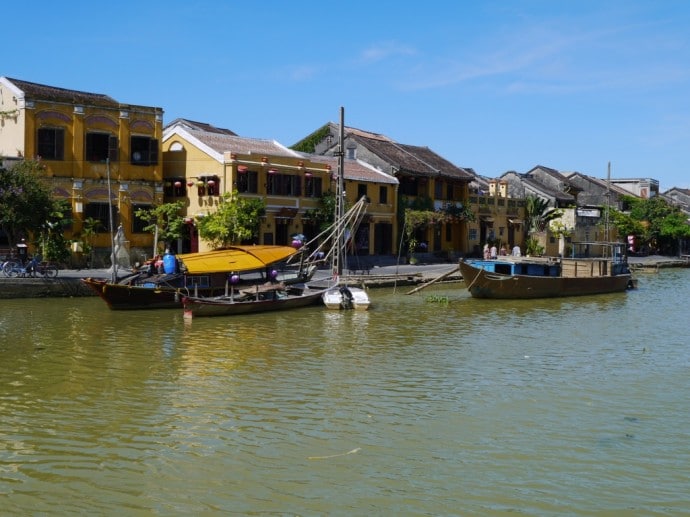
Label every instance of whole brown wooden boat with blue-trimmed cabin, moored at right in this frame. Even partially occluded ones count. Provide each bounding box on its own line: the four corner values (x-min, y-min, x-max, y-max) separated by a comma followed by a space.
460, 243, 636, 299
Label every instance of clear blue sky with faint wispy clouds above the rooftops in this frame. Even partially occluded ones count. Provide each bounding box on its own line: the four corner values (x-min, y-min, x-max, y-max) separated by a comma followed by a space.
5, 0, 690, 192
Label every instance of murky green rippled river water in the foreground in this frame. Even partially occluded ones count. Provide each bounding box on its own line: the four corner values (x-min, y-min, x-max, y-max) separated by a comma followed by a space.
0, 270, 690, 516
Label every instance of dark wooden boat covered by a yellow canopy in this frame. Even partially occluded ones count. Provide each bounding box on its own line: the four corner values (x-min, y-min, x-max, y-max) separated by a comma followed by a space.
82, 245, 316, 310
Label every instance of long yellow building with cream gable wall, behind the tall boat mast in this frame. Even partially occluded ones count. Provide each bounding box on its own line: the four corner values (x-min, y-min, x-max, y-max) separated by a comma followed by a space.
162, 119, 397, 254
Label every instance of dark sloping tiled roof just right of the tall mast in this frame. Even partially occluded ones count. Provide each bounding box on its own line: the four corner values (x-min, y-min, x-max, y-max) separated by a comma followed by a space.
353, 135, 473, 181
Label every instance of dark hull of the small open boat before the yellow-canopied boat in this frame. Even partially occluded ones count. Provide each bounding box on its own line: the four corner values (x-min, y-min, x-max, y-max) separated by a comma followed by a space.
182, 288, 323, 318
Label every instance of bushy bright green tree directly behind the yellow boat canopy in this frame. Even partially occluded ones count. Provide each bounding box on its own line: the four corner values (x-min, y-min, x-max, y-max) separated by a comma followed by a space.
198, 191, 266, 248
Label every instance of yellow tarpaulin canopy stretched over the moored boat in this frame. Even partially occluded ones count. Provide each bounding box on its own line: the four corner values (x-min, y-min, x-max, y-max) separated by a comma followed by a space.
177, 245, 297, 274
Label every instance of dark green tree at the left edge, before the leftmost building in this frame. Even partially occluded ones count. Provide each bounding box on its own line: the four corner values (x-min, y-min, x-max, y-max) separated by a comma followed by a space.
0, 160, 56, 247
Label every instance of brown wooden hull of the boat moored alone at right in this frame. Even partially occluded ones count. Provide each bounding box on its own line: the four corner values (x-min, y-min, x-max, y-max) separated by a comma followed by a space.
460, 262, 633, 299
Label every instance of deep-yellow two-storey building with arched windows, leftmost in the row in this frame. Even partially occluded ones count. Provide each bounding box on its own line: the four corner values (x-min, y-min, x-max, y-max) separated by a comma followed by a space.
0, 77, 163, 265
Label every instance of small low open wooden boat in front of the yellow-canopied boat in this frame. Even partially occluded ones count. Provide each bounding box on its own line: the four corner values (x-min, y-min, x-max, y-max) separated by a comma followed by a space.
182, 283, 323, 318
